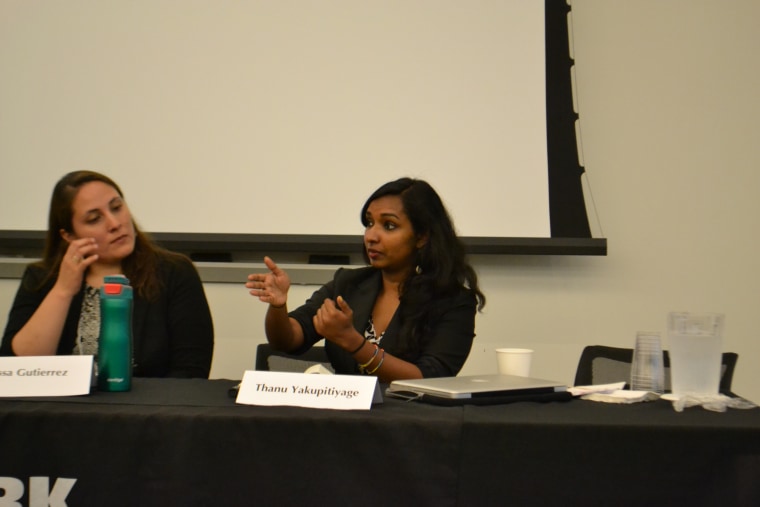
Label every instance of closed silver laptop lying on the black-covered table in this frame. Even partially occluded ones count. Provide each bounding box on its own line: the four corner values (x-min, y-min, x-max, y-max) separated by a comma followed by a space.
386, 374, 567, 399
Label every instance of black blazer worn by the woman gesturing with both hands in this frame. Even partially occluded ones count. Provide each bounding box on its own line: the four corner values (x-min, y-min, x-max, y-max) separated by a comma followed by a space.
290, 267, 476, 377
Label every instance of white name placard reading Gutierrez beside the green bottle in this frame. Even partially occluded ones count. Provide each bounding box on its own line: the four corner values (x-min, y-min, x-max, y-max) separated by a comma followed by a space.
0, 355, 93, 398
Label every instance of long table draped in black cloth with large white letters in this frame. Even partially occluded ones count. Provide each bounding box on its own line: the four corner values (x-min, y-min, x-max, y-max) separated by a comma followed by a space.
0, 379, 760, 506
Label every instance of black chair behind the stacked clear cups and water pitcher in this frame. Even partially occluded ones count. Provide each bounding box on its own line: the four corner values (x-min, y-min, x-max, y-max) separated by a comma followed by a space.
574, 345, 739, 395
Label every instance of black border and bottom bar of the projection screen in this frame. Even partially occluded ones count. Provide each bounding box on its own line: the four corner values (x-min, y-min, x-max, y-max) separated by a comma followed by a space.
0, 0, 607, 261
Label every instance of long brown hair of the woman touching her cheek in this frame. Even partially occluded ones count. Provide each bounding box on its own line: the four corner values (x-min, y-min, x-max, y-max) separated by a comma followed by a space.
35, 171, 183, 300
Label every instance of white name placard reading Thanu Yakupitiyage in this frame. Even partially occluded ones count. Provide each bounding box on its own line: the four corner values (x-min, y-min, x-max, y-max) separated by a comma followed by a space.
235, 370, 377, 410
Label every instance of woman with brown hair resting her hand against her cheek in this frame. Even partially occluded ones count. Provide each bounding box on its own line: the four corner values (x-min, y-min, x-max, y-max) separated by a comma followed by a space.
0, 171, 214, 378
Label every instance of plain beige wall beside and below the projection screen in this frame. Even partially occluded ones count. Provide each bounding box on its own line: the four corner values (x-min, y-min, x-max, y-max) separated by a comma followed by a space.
0, 0, 760, 401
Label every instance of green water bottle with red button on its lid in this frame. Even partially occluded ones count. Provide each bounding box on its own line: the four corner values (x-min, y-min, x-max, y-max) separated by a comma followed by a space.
98, 275, 133, 391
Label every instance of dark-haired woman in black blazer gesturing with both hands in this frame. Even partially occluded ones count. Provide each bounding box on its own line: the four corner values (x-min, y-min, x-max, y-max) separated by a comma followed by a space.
246, 178, 485, 382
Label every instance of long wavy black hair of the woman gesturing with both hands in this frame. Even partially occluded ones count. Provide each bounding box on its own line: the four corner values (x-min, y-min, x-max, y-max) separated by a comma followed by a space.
361, 178, 486, 350
